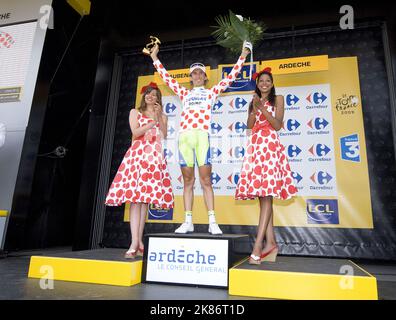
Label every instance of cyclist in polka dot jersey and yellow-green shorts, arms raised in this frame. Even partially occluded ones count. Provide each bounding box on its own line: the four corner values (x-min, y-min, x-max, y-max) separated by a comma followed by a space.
151, 41, 252, 234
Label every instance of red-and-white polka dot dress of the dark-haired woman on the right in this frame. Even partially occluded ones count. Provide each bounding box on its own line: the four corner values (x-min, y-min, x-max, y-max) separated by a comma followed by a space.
235, 101, 297, 200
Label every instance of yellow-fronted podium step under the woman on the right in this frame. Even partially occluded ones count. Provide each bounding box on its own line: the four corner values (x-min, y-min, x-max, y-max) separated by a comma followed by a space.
229, 256, 378, 300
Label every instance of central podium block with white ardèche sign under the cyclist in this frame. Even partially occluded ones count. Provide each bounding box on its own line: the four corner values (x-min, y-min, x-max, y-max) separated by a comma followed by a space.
142, 233, 249, 288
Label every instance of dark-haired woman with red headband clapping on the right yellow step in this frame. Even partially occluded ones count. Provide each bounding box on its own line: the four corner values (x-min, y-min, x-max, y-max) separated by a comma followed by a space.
235, 68, 297, 264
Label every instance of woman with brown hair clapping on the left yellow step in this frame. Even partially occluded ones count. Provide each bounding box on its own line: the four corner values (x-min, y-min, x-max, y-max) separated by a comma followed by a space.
105, 82, 173, 258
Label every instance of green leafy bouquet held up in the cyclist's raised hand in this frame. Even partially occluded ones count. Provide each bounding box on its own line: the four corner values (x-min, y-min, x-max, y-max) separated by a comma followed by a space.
212, 10, 267, 53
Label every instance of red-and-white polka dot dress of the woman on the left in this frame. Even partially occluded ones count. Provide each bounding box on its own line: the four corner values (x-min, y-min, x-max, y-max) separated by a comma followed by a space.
105, 112, 174, 209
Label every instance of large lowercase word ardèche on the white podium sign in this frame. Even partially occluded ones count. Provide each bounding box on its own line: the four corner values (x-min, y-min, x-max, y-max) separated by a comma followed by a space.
148, 249, 216, 264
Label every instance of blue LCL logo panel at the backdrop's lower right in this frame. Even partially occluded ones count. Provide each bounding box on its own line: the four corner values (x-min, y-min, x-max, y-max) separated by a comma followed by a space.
307, 199, 339, 224
